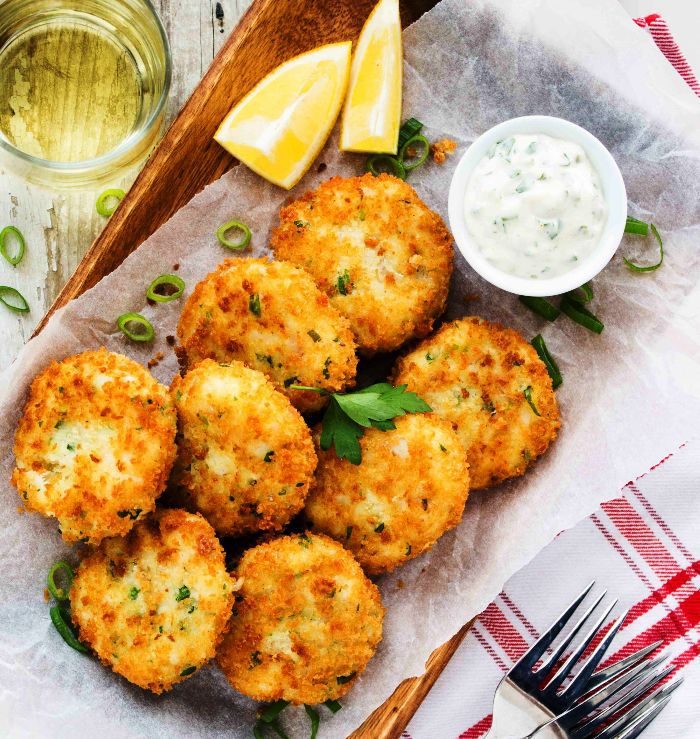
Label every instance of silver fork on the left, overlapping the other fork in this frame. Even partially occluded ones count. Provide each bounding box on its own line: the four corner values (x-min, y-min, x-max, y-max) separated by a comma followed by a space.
487, 582, 660, 739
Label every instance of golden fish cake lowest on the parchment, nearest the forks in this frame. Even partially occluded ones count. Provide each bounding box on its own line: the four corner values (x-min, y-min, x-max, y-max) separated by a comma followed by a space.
217, 534, 384, 704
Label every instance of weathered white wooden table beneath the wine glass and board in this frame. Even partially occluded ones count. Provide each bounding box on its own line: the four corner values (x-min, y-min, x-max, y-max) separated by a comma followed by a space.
0, 0, 700, 370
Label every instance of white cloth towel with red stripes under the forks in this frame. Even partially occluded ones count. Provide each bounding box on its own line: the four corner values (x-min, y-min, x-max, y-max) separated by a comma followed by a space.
403, 20, 700, 739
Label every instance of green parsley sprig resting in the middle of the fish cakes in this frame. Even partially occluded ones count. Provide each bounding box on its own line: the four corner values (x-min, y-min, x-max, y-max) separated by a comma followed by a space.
291, 382, 432, 464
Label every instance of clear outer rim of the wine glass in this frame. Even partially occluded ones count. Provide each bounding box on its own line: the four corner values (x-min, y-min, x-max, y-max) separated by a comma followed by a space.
0, 0, 173, 176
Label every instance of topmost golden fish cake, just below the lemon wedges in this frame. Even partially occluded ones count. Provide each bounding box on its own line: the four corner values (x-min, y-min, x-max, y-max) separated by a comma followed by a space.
271, 174, 453, 355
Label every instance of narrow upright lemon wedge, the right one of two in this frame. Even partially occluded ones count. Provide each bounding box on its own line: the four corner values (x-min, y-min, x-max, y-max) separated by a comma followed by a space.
340, 0, 403, 154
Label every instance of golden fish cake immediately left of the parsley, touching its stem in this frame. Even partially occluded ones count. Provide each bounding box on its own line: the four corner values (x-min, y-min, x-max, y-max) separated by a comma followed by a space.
172, 359, 316, 536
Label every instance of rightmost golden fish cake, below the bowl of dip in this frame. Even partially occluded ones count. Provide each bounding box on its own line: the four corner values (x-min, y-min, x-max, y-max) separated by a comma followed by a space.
394, 318, 561, 490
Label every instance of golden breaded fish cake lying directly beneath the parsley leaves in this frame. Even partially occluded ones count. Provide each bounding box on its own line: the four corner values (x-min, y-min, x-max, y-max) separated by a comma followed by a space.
305, 413, 469, 574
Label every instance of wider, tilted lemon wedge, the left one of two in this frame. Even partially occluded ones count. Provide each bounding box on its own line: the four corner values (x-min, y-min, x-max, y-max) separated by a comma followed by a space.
214, 41, 351, 190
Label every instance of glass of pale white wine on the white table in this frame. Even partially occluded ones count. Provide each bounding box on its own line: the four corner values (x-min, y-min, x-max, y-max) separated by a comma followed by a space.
0, 0, 171, 187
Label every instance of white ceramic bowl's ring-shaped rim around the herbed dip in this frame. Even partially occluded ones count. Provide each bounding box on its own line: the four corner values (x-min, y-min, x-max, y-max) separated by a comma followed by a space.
448, 115, 627, 296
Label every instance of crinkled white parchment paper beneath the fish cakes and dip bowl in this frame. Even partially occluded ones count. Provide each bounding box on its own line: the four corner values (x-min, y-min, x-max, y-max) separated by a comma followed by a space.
0, 0, 700, 739
